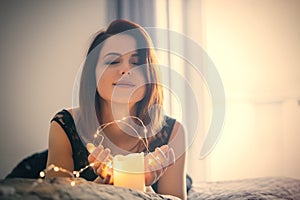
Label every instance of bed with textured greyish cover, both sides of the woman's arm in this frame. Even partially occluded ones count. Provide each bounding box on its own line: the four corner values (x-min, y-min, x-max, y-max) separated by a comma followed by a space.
0, 177, 300, 200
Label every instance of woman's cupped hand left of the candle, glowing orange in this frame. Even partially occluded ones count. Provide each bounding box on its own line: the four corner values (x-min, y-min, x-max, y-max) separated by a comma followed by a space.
86, 143, 113, 184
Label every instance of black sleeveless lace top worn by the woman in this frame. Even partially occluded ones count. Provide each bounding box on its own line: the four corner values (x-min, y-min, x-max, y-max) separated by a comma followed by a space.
51, 110, 175, 189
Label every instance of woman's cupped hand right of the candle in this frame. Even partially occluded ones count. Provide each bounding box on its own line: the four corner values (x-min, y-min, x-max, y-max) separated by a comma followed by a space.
144, 145, 175, 186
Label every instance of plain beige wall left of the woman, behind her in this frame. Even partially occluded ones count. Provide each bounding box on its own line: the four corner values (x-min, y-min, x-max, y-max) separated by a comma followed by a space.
0, 0, 105, 178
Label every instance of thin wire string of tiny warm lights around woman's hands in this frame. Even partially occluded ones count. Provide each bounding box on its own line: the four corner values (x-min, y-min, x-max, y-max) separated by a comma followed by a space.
39, 116, 159, 186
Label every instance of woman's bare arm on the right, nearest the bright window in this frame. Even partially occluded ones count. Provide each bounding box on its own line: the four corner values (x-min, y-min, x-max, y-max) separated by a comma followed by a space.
158, 122, 187, 199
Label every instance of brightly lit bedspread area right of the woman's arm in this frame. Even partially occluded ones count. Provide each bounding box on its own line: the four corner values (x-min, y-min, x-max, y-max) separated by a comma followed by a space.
188, 177, 300, 200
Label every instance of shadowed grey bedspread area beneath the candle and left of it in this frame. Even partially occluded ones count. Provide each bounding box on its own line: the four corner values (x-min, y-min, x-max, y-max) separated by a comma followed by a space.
0, 178, 178, 200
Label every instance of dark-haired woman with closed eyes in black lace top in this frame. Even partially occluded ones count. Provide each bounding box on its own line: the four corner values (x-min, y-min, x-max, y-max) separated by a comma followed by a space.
46, 20, 186, 199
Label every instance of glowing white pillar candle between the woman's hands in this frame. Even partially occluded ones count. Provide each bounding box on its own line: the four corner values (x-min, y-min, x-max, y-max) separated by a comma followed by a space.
113, 152, 145, 191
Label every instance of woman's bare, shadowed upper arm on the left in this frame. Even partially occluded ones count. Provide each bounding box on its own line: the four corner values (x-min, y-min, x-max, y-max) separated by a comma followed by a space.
46, 121, 74, 177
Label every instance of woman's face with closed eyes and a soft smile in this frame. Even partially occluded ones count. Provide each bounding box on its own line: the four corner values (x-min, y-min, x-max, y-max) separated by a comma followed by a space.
96, 34, 146, 104
